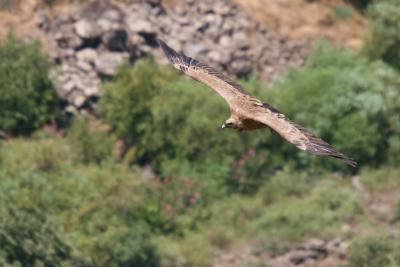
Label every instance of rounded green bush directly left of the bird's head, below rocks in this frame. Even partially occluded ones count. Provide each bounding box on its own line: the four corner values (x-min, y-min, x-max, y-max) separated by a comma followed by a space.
101, 60, 265, 186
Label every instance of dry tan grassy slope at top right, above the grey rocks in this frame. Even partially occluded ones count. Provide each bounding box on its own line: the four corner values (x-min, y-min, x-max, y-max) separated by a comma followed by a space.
233, 0, 368, 49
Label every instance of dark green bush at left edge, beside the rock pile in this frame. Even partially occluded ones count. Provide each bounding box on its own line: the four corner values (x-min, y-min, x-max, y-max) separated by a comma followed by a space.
0, 34, 58, 134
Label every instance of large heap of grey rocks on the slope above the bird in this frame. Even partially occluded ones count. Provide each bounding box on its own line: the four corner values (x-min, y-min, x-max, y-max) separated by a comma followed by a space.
38, 0, 306, 113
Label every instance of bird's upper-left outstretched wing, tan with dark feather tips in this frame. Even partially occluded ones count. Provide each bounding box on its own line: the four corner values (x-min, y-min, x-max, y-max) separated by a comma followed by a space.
157, 39, 258, 107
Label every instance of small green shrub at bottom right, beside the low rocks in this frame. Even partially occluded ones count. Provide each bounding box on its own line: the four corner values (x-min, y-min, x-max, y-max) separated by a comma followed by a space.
348, 235, 392, 267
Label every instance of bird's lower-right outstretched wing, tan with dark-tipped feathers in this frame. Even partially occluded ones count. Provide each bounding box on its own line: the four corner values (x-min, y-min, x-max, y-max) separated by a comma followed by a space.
249, 104, 357, 167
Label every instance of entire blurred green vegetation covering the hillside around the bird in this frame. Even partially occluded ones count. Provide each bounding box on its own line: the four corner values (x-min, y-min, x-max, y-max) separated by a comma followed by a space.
0, 0, 400, 267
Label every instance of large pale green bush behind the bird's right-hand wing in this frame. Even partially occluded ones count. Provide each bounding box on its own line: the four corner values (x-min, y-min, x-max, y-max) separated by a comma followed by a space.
269, 44, 400, 171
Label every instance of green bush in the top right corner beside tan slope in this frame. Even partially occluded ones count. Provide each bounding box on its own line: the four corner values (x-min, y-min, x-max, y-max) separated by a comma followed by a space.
365, 0, 400, 69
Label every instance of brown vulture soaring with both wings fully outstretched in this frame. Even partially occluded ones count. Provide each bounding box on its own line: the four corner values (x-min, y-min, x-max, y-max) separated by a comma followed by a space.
157, 39, 357, 167
